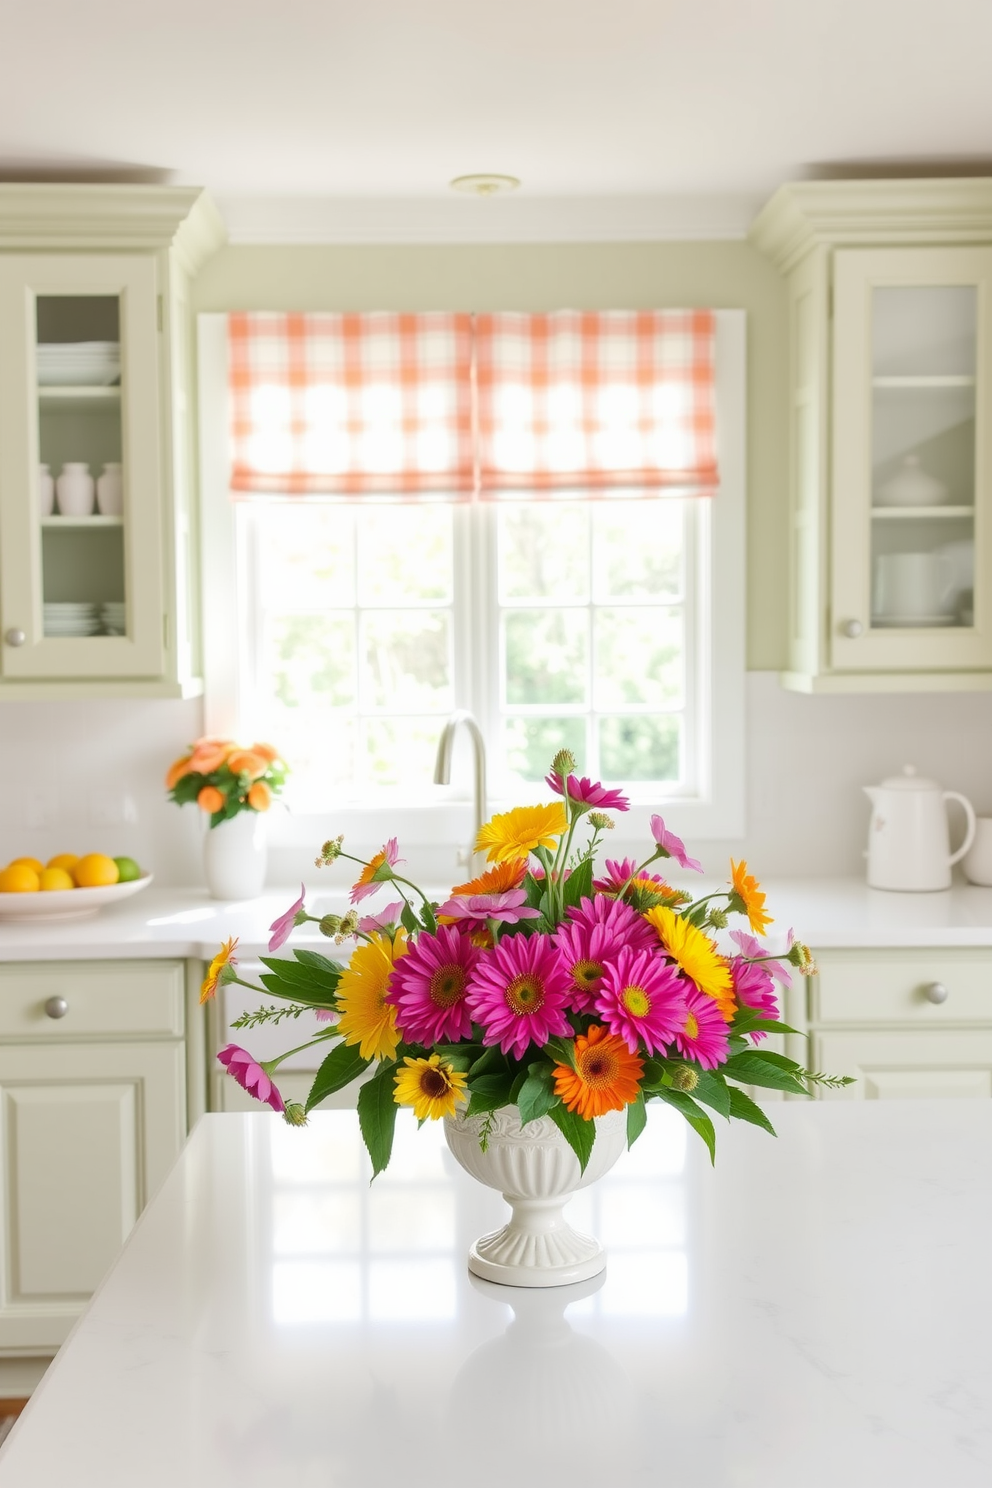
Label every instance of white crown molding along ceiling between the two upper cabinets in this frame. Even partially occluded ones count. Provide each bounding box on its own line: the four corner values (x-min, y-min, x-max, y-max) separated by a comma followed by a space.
219, 195, 760, 244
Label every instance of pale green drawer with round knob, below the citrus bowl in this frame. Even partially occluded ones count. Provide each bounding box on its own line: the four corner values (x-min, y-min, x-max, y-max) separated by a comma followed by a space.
0, 961, 184, 1040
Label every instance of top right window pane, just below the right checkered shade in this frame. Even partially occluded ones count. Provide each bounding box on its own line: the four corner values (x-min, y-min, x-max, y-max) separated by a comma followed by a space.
592, 500, 686, 600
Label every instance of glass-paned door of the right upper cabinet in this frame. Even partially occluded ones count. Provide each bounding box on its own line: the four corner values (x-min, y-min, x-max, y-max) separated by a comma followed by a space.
830, 248, 992, 673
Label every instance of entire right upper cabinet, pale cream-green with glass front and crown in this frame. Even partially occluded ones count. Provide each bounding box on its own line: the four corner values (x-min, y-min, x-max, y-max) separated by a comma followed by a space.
751, 180, 992, 692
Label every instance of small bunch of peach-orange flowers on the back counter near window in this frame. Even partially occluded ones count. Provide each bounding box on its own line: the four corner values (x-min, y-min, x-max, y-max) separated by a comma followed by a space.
165, 738, 289, 827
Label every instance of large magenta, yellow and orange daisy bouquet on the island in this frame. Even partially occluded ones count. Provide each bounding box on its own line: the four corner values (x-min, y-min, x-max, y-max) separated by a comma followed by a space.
201, 750, 848, 1173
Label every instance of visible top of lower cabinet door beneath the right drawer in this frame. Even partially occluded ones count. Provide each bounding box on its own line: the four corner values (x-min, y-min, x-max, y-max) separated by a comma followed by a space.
812, 1028, 992, 1101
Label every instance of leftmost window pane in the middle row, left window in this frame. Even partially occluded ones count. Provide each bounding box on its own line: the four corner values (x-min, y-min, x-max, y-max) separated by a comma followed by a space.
263, 615, 355, 708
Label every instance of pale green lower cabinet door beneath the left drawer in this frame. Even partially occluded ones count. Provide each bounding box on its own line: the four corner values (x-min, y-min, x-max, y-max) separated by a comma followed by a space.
0, 1042, 186, 1348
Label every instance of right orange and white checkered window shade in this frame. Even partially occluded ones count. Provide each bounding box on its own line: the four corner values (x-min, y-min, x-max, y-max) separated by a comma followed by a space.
476, 310, 717, 497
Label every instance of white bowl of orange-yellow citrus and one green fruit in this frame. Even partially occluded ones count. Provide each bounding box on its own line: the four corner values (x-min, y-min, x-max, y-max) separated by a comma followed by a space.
0, 853, 152, 923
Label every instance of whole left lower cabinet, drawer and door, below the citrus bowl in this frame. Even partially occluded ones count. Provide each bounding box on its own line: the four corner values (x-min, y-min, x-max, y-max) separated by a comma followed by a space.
0, 961, 204, 1356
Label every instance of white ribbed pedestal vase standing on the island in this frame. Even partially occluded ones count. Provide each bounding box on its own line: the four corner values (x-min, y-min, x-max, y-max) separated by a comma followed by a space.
445, 1106, 626, 1287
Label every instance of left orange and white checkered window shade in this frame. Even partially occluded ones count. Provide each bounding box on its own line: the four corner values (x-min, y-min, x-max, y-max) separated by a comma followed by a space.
228, 311, 474, 498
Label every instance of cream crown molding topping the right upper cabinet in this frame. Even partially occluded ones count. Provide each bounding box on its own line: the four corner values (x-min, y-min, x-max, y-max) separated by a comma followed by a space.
748, 176, 992, 272
